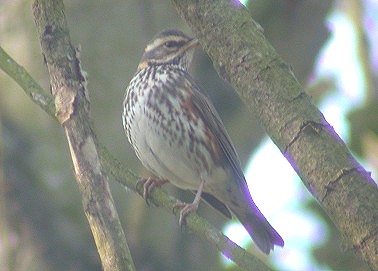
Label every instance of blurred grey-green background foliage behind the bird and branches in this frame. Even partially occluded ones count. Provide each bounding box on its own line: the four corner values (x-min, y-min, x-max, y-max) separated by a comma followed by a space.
0, 0, 378, 271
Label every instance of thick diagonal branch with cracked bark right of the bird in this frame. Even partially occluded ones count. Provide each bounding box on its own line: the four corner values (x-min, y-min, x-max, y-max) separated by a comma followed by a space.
173, 0, 378, 270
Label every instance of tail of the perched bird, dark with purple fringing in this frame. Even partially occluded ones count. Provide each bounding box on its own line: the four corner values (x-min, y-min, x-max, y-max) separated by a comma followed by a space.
234, 201, 284, 254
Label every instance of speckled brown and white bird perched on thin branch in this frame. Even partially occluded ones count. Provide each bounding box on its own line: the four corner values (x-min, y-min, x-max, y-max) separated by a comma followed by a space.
122, 29, 284, 254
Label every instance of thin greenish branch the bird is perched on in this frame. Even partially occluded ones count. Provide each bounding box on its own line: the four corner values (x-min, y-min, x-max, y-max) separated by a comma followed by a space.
0, 5, 272, 271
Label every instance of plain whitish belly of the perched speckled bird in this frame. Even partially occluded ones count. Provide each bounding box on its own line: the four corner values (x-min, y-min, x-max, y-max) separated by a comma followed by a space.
131, 103, 227, 192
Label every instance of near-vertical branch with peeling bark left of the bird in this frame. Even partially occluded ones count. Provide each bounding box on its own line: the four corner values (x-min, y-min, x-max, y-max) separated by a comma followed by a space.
33, 0, 135, 270
